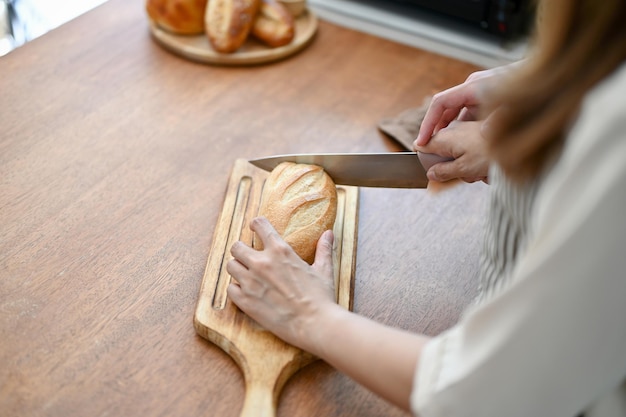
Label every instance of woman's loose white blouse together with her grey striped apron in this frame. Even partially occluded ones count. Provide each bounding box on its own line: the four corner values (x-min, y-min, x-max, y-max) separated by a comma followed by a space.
411, 65, 626, 417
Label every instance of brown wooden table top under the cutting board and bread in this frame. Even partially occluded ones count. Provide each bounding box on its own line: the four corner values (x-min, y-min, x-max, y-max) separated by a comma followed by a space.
0, 0, 487, 417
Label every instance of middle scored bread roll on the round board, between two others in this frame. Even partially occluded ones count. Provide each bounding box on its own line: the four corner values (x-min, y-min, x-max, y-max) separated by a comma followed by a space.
204, 0, 261, 53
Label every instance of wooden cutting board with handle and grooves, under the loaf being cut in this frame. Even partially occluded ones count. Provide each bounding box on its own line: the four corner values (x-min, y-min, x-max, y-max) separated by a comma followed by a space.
194, 159, 359, 417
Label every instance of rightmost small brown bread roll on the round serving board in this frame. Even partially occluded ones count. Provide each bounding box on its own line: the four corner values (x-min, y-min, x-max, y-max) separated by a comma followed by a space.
252, 0, 295, 47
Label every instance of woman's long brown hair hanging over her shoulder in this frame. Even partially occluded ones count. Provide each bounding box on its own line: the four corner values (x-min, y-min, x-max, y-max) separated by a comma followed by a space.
485, 0, 626, 180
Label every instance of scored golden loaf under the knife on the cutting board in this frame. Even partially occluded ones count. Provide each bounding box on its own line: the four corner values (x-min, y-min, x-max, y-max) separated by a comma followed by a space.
253, 162, 337, 264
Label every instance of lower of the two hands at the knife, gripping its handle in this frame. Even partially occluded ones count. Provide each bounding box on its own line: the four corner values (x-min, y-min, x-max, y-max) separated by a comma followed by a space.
416, 120, 489, 182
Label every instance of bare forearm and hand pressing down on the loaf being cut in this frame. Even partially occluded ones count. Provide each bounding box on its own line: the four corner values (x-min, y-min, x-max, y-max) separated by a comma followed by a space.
227, 218, 428, 410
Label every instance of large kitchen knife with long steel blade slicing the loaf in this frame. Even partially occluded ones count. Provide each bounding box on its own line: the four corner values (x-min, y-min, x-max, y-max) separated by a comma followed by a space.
249, 152, 451, 188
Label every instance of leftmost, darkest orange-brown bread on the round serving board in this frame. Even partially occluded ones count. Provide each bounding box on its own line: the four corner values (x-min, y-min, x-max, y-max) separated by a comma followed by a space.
146, 0, 207, 35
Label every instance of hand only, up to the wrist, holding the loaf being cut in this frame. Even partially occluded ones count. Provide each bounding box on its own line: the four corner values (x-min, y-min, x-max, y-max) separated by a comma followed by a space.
226, 217, 337, 354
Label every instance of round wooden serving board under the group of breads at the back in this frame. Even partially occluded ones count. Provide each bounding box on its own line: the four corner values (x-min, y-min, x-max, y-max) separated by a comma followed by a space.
150, 10, 318, 65
